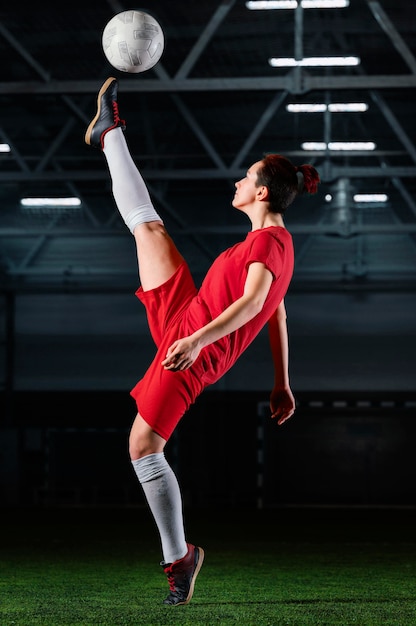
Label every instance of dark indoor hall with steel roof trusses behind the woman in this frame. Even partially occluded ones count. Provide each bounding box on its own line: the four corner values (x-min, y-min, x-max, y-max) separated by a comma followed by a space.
0, 0, 416, 509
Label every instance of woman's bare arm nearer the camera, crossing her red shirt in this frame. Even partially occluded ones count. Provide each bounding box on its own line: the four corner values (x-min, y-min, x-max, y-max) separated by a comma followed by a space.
162, 262, 273, 371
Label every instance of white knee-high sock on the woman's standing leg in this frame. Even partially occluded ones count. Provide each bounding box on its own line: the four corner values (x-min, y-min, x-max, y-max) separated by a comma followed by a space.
132, 452, 188, 563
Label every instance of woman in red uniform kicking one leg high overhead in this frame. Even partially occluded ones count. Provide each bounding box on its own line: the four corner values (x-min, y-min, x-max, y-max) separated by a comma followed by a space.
85, 78, 319, 605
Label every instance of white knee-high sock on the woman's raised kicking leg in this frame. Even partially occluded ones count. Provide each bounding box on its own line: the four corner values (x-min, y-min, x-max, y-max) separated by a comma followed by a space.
103, 127, 162, 233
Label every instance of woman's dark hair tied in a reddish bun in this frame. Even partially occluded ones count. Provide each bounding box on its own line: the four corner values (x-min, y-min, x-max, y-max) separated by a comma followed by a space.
256, 154, 320, 214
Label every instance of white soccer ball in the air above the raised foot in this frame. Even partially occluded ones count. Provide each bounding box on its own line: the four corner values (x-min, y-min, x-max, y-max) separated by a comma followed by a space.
102, 11, 165, 74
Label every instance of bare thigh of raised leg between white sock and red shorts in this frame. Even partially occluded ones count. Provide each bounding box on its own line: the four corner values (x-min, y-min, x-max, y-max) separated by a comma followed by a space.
134, 221, 183, 291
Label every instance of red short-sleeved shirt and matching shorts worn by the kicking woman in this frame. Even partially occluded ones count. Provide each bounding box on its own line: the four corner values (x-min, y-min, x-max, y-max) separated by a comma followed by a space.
131, 226, 294, 440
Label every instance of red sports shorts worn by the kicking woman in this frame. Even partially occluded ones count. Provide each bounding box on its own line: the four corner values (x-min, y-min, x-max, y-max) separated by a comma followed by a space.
131, 263, 206, 440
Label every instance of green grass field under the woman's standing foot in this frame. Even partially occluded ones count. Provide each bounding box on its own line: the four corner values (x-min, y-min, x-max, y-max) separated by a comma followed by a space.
0, 509, 416, 626
